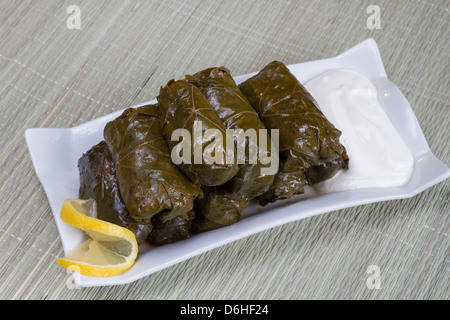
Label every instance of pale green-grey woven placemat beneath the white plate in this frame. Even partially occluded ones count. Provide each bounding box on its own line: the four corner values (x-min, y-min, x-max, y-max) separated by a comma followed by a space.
0, 0, 450, 299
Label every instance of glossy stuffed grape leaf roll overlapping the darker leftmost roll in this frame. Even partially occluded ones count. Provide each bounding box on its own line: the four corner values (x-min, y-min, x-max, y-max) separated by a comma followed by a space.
104, 105, 202, 222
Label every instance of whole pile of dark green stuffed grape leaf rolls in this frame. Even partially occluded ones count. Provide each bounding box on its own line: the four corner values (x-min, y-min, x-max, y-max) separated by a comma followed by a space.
78, 61, 349, 245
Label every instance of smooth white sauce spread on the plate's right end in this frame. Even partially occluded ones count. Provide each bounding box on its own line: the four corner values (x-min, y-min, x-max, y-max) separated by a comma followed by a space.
305, 69, 414, 192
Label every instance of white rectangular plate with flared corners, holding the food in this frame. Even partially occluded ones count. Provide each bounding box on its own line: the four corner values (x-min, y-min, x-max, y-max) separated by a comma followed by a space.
25, 39, 450, 287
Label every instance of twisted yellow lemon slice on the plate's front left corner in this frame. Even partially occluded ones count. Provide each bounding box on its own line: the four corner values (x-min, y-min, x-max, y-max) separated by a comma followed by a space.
56, 199, 138, 277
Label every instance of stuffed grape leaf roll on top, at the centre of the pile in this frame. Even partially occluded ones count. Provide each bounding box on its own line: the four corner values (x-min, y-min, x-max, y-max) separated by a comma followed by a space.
157, 80, 239, 186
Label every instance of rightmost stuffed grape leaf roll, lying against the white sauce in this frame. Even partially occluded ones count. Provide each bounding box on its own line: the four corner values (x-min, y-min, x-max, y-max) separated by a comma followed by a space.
239, 61, 348, 202
